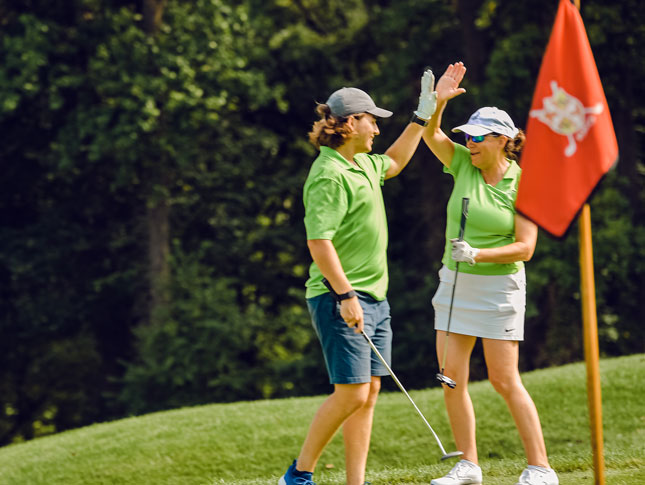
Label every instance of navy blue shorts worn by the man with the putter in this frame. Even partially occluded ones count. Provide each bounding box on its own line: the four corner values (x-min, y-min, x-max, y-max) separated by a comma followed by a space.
307, 292, 392, 384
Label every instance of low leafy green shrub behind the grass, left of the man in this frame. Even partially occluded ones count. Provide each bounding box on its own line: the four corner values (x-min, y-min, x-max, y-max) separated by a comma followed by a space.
120, 249, 325, 414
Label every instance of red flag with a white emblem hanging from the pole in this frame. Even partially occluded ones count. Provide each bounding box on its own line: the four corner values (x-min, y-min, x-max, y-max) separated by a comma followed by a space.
516, 0, 618, 237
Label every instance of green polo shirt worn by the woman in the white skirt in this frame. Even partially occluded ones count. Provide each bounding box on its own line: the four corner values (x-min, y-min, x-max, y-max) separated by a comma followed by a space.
441, 143, 524, 275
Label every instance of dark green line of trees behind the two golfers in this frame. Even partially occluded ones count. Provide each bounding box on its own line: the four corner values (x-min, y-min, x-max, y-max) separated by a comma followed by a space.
0, 0, 645, 444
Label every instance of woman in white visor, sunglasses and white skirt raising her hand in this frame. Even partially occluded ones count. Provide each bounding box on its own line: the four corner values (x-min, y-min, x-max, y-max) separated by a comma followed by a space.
424, 62, 558, 485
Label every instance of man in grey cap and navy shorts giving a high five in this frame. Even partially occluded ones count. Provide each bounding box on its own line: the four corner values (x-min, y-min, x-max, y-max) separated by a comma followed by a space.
279, 70, 436, 485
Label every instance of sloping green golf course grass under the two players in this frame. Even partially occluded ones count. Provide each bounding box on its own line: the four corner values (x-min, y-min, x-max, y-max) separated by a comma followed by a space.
0, 355, 645, 485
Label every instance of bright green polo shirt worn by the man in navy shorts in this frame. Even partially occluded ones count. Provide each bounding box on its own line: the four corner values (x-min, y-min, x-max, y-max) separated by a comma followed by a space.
303, 146, 391, 300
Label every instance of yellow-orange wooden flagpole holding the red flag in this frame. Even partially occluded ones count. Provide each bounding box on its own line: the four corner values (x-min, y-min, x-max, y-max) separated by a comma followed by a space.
573, 0, 605, 485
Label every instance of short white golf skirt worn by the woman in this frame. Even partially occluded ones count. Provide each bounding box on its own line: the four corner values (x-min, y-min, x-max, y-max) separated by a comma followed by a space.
432, 263, 526, 340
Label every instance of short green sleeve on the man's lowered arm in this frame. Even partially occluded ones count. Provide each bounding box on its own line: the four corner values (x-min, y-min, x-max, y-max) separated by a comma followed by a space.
304, 178, 348, 240
